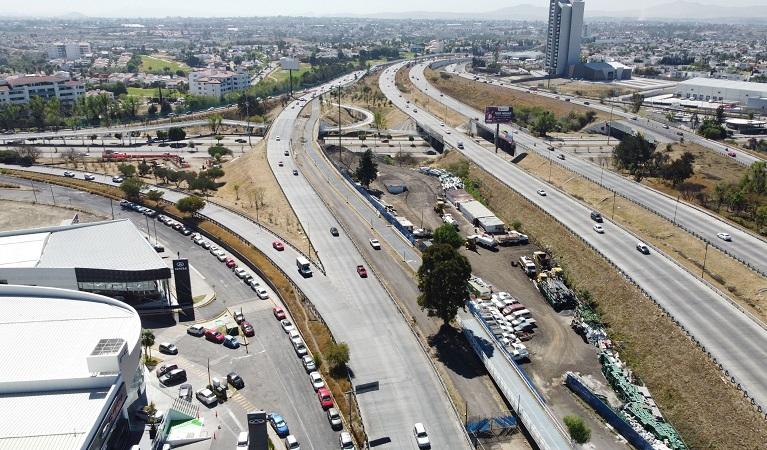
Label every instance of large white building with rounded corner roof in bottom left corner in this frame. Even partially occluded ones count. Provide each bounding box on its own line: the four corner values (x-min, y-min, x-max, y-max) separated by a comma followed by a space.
0, 285, 146, 450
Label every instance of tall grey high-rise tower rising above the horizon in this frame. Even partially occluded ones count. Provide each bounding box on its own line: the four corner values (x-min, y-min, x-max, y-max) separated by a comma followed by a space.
545, 0, 584, 77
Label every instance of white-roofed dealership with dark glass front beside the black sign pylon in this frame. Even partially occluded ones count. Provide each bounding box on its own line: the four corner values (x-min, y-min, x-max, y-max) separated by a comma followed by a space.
0, 219, 171, 307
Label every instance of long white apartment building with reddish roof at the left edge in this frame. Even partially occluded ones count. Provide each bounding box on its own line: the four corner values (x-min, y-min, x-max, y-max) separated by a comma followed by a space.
0, 72, 85, 104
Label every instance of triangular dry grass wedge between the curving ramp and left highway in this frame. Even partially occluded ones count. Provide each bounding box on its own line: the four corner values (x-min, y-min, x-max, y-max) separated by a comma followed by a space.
213, 141, 307, 248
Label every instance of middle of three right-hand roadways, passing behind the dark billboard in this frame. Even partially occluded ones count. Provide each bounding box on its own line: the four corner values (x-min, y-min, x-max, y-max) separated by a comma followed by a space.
410, 64, 767, 275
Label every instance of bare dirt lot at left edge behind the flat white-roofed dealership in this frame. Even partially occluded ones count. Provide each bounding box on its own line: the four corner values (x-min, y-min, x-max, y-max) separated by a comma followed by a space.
0, 200, 107, 231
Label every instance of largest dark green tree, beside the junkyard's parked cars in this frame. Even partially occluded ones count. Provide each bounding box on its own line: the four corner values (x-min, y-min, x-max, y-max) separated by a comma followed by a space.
418, 244, 471, 324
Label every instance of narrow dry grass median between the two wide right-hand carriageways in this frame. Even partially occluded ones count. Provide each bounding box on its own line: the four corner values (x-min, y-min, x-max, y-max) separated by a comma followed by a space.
519, 154, 767, 321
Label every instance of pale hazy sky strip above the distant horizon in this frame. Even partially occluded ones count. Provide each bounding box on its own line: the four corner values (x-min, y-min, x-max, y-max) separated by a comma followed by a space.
0, 0, 767, 17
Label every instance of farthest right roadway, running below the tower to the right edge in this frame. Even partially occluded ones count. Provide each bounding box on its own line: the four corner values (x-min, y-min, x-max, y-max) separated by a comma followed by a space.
447, 59, 765, 166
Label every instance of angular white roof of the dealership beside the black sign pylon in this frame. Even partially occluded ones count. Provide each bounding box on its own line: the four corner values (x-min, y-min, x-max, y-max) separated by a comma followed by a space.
0, 219, 168, 271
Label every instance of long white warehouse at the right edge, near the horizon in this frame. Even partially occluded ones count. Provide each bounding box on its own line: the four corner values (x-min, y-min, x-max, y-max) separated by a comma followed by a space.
674, 78, 767, 111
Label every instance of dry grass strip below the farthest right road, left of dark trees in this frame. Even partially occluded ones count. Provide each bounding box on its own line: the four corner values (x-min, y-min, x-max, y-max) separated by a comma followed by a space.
424, 69, 608, 122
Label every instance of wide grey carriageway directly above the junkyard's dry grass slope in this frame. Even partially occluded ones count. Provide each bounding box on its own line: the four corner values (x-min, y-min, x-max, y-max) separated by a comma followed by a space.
379, 60, 767, 418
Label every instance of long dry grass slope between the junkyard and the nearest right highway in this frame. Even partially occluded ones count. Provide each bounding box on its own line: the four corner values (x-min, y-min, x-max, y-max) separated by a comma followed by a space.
432, 152, 767, 449
